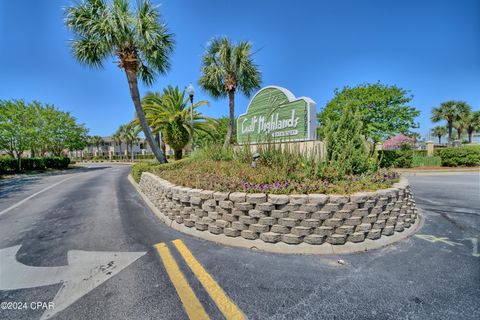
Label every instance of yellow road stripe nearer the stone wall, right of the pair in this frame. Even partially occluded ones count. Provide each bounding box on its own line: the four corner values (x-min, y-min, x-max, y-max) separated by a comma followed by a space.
172, 239, 245, 320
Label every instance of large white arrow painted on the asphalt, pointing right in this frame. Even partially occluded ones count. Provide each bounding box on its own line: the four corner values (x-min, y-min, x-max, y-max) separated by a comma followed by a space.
0, 246, 145, 320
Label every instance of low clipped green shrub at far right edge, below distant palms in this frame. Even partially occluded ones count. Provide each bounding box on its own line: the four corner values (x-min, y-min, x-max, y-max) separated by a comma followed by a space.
436, 146, 480, 167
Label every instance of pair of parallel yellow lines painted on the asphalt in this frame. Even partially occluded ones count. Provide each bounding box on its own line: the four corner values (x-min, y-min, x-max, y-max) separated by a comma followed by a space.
155, 239, 245, 320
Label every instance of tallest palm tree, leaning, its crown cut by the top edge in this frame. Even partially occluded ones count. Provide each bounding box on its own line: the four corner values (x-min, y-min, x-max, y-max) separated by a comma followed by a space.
65, 0, 174, 163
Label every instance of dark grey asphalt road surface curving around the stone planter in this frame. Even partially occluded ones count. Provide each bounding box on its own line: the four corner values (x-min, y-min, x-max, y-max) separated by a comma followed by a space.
0, 165, 480, 319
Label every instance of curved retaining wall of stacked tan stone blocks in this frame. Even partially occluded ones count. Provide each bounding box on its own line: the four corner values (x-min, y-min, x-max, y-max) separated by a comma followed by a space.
139, 172, 417, 245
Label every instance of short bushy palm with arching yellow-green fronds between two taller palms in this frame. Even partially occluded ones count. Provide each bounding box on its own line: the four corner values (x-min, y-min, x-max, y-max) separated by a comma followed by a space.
142, 86, 212, 160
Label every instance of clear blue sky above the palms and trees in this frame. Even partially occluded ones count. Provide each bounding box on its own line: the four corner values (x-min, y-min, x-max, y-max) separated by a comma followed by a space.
0, 0, 480, 135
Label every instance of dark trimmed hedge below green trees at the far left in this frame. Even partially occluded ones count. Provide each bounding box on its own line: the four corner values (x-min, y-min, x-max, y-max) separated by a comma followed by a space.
0, 157, 70, 174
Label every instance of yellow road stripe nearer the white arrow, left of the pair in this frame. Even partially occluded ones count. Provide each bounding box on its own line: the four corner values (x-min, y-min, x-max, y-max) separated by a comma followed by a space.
155, 242, 210, 320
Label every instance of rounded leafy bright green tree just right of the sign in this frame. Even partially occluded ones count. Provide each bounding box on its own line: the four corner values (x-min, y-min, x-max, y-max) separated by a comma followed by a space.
317, 83, 420, 143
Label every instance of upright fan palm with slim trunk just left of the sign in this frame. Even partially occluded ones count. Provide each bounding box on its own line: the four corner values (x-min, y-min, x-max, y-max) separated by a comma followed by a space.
199, 37, 262, 148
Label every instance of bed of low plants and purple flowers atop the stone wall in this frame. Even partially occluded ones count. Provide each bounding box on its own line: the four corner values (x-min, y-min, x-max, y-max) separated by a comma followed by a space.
133, 159, 399, 194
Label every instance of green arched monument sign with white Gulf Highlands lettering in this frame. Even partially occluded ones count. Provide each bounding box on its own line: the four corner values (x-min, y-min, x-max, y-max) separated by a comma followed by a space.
237, 86, 316, 144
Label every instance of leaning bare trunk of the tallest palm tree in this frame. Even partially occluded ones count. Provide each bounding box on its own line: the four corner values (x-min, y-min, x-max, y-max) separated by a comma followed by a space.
125, 68, 166, 163
